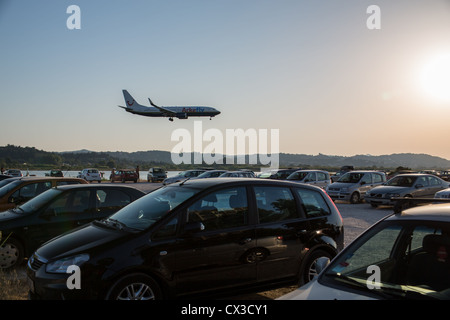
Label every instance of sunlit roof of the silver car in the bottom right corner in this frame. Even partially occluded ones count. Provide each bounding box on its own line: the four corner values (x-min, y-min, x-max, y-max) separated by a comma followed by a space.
388, 203, 450, 222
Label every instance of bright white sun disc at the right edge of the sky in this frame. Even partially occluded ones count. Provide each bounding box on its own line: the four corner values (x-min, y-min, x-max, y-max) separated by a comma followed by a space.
420, 53, 450, 101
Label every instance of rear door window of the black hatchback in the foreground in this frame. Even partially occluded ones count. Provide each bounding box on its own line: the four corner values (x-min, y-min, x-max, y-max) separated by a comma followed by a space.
254, 186, 299, 223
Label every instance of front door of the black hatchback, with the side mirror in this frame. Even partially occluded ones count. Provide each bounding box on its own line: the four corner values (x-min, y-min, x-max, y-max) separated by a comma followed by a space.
160, 186, 256, 293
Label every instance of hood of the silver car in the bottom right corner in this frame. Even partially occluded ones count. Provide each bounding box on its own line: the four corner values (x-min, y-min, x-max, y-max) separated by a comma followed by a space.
277, 279, 375, 300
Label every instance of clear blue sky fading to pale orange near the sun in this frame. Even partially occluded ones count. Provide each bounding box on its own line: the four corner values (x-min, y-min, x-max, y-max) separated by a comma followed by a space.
0, 0, 450, 159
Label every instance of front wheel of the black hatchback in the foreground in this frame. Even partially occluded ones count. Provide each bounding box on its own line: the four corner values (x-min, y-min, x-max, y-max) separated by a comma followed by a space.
107, 273, 162, 300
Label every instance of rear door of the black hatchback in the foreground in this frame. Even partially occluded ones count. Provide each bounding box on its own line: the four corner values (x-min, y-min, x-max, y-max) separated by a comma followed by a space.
253, 186, 309, 281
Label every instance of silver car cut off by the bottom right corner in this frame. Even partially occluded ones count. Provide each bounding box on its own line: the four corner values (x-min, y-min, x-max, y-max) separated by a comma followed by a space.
279, 200, 450, 300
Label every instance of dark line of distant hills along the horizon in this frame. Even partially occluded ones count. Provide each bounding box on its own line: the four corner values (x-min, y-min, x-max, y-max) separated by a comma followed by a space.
0, 145, 450, 170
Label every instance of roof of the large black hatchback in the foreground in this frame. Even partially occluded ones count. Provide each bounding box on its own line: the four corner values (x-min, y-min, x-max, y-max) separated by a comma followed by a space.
167, 177, 320, 190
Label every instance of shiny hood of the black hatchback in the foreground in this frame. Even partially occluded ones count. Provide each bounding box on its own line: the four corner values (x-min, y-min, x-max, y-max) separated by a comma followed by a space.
36, 222, 128, 260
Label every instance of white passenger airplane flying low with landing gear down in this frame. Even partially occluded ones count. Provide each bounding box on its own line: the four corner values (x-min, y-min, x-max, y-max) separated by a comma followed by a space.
119, 90, 220, 121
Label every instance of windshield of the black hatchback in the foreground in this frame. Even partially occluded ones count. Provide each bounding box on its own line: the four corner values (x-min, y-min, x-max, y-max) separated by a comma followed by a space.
108, 186, 200, 230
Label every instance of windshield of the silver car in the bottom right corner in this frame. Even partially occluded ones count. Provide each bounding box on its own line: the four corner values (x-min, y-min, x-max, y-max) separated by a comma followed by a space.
319, 221, 450, 299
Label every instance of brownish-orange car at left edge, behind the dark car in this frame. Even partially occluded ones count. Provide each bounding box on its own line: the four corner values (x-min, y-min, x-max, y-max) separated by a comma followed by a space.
0, 177, 87, 211
